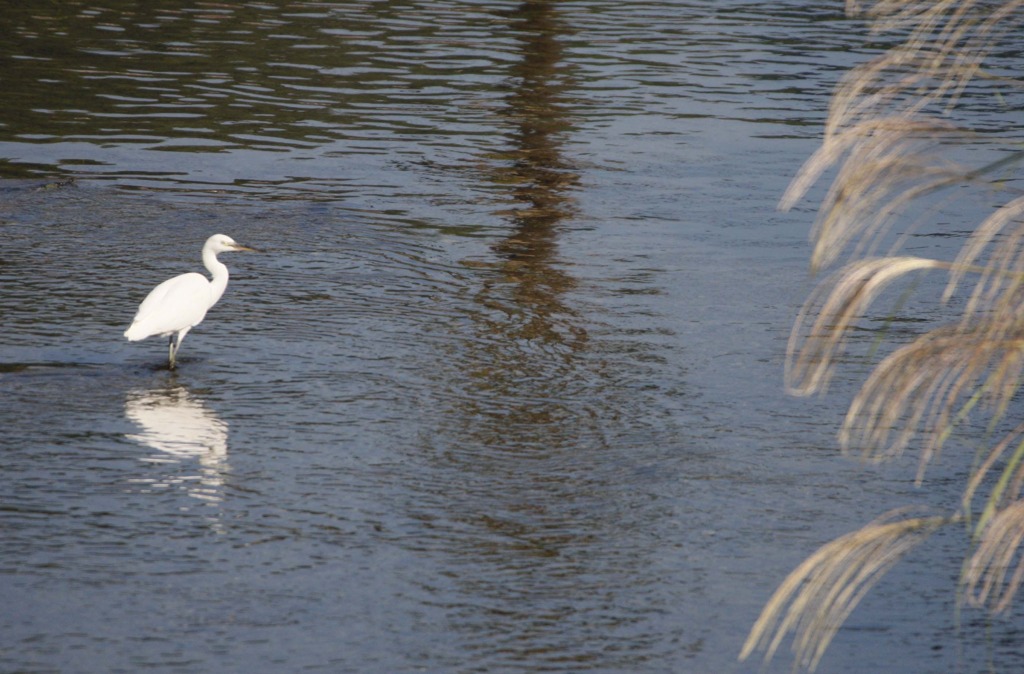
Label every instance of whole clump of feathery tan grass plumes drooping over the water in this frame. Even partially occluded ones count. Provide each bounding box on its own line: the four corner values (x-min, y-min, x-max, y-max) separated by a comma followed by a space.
753, 0, 1024, 670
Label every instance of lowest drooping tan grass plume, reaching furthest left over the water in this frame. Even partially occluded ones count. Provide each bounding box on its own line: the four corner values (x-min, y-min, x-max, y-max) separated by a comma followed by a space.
739, 512, 948, 671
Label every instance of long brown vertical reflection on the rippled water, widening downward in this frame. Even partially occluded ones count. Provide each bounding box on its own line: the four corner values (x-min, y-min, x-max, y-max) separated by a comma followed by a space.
421, 1, 646, 669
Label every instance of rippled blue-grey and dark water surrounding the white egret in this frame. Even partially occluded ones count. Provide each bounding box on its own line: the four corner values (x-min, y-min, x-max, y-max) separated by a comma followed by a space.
0, 0, 1024, 672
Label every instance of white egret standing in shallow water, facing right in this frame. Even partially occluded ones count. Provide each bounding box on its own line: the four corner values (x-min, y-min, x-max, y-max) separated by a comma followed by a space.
125, 234, 257, 370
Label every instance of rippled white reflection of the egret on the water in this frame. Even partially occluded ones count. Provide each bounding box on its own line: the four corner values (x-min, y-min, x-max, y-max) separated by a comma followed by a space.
125, 385, 227, 504
